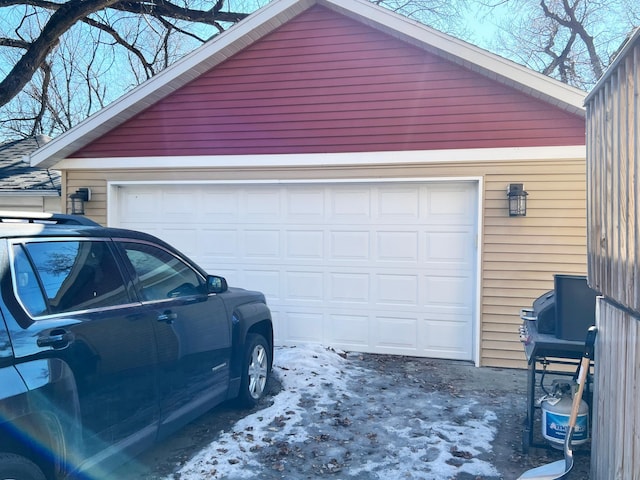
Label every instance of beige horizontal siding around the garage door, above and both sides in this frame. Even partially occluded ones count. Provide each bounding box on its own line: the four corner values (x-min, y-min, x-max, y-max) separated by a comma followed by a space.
67, 159, 586, 368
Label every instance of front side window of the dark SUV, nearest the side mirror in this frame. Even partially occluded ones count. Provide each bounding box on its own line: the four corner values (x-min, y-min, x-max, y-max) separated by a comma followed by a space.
120, 242, 206, 301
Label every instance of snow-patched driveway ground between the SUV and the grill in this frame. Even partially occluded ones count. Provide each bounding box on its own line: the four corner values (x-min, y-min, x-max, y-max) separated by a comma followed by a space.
113, 347, 590, 480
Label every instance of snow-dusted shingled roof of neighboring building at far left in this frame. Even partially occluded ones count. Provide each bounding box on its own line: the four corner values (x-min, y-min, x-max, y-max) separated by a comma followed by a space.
0, 135, 60, 195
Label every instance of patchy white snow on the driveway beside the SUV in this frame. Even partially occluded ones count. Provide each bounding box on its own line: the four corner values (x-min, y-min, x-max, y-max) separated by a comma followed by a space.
172, 345, 499, 480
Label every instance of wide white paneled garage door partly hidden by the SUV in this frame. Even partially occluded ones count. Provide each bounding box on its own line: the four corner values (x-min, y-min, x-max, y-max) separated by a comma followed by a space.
112, 182, 478, 360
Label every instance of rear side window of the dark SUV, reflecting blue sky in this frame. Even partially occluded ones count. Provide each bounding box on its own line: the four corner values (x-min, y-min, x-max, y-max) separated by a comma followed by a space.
14, 240, 131, 317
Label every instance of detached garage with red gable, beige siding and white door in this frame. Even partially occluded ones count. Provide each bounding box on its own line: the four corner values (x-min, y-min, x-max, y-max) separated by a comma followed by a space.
32, 0, 586, 366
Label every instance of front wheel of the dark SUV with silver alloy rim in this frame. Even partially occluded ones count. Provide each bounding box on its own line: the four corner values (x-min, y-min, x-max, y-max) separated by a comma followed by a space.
238, 333, 271, 407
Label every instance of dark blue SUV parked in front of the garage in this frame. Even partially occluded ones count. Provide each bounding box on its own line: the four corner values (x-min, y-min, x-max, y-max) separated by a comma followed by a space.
0, 213, 273, 480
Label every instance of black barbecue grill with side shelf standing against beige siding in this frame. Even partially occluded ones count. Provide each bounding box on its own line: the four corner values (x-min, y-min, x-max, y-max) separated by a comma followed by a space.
520, 275, 598, 453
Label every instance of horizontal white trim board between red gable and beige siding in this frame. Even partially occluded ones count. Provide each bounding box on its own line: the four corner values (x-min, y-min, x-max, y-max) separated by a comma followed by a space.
56, 145, 586, 170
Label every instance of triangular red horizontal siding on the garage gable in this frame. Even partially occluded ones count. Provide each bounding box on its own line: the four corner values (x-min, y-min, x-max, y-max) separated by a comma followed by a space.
73, 7, 585, 157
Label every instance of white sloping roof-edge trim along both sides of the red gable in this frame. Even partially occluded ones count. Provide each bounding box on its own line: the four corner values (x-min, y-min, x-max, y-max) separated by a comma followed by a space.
31, 0, 585, 167
